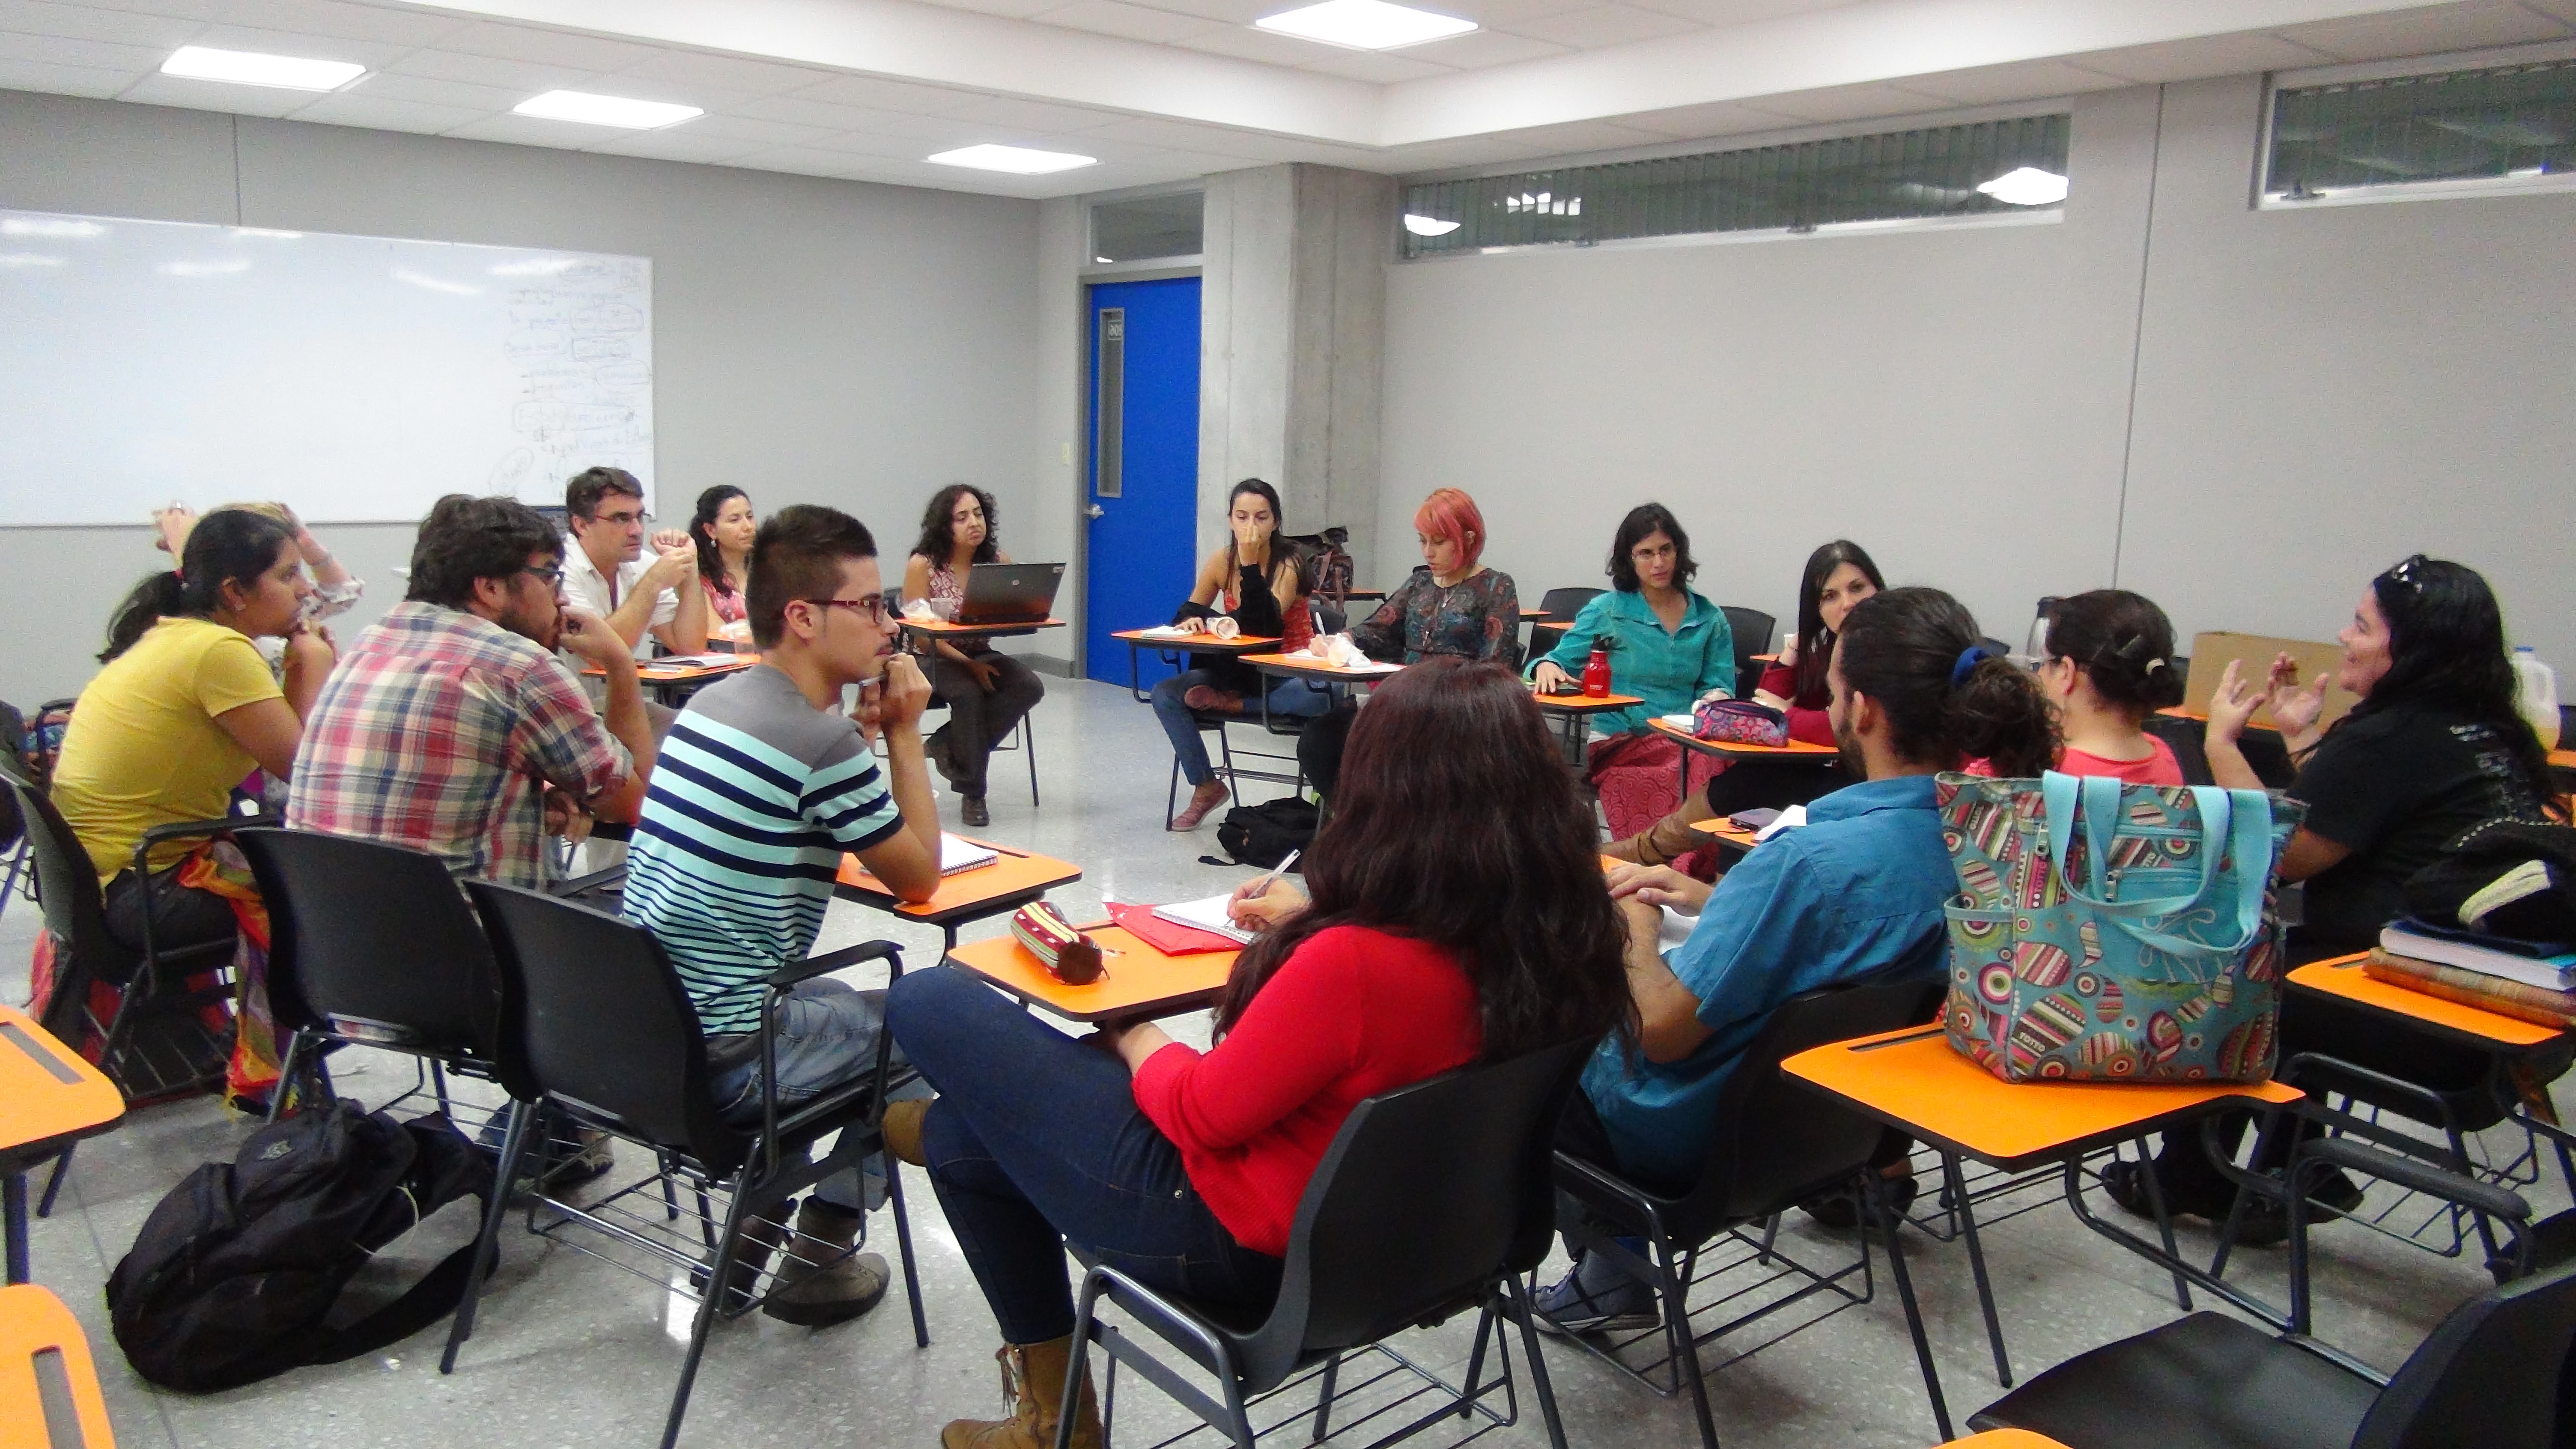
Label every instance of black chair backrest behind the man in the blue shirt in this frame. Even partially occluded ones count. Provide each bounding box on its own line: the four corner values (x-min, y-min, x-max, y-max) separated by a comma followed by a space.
1667, 975, 1942, 1240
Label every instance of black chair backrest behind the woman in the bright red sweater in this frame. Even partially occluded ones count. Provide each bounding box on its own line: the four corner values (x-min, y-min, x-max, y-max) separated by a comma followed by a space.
1242, 1042, 1592, 1390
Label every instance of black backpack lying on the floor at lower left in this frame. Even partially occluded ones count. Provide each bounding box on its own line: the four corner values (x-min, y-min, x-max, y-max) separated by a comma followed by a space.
108, 1101, 492, 1392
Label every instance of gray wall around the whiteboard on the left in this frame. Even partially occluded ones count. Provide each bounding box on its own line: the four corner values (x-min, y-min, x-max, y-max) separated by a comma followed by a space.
0, 90, 1054, 701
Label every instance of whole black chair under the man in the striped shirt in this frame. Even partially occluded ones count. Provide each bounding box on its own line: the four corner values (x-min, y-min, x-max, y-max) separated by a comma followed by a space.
458, 882, 930, 1449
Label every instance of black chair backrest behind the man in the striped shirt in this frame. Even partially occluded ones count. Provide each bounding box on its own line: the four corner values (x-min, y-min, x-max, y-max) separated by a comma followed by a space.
466, 882, 750, 1176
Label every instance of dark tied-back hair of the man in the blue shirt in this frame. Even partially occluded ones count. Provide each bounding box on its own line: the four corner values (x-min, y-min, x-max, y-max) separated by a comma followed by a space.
1834, 588, 2058, 776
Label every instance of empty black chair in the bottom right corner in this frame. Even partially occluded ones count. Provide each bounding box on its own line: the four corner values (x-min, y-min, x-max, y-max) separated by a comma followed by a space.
1968, 1227, 2576, 1449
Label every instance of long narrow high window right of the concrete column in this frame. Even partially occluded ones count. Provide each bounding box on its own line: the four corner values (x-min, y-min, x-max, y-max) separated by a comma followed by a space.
1404, 113, 2069, 258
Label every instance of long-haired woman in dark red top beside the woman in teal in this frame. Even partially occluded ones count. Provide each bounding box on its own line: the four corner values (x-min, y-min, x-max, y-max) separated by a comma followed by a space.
1602, 539, 1888, 866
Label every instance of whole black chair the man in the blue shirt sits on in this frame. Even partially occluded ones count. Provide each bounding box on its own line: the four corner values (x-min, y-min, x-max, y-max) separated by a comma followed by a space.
1556, 980, 1950, 1449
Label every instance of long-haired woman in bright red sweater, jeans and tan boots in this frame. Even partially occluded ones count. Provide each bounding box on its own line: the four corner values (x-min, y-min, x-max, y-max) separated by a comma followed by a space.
886, 657, 1633, 1449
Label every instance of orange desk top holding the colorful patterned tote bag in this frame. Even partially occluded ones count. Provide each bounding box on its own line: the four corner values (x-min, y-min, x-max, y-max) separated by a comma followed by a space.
1780, 1026, 2300, 1171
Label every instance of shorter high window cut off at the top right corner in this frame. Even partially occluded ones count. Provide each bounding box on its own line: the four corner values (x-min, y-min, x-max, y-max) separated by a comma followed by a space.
2264, 59, 2576, 201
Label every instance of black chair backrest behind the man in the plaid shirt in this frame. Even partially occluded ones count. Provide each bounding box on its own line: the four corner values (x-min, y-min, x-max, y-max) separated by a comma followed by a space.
234, 830, 500, 1062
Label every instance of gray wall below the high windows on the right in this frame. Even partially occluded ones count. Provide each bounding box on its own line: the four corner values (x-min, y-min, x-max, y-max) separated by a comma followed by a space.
1376, 78, 2576, 668
